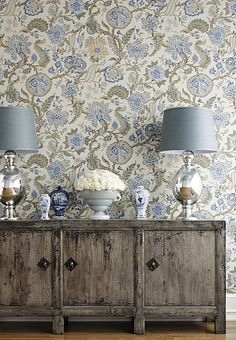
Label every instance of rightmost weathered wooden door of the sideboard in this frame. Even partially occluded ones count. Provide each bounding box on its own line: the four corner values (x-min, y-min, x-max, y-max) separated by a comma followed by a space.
145, 231, 215, 305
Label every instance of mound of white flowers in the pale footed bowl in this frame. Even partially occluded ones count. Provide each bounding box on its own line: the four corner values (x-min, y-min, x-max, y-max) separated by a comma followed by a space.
76, 169, 125, 191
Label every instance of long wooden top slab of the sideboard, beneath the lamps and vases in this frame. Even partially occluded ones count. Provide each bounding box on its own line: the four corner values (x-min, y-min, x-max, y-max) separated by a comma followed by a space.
0, 219, 225, 231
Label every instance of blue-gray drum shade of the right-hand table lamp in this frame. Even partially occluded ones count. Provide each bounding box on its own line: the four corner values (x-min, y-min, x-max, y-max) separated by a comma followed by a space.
160, 107, 217, 154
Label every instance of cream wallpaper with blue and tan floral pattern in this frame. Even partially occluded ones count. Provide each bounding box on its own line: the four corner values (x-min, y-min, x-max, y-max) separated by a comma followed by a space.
0, 0, 236, 293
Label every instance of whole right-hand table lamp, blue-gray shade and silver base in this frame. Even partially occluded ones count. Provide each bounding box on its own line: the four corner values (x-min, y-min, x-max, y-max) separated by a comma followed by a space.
160, 107, 217, 220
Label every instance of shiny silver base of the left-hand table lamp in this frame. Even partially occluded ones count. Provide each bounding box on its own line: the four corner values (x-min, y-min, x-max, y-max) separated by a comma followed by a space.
0, 151, 25, 221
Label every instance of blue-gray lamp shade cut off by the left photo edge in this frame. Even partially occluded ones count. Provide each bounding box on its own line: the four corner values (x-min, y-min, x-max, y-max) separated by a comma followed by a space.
0, 107, 38, 153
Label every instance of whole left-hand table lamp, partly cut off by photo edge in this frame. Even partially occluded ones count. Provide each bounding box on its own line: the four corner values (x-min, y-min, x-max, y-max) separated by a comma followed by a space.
0, 107, 38, 220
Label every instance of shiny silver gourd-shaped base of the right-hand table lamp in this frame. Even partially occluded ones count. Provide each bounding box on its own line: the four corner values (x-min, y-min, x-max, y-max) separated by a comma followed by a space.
172, 151, 202, 220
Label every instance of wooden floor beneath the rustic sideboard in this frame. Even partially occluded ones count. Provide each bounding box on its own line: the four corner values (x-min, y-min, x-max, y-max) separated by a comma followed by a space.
0, 321, 236, 340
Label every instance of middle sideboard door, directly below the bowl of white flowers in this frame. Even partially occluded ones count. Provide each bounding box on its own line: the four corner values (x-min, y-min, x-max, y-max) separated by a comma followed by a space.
64, 231, 134, 305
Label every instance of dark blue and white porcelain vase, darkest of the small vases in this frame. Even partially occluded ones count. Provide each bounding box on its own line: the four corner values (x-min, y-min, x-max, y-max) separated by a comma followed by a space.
50, 185, 69, 219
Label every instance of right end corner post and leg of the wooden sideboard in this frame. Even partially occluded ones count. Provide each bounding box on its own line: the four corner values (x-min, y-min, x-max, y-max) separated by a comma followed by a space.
215, 226, 226, 334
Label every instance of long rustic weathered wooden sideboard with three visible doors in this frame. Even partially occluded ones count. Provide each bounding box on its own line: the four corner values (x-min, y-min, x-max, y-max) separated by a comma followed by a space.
0, 219, 225, 334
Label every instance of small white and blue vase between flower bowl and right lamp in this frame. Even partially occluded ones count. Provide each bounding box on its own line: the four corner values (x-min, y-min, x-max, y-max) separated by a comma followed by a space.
131, 185, 149, 219
